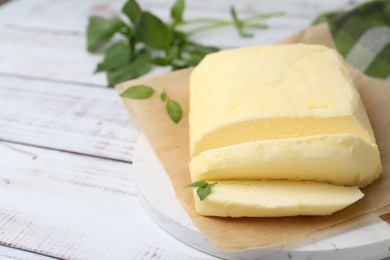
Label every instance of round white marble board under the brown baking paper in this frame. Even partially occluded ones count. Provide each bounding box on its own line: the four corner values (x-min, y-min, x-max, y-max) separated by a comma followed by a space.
133, 135, 390, 260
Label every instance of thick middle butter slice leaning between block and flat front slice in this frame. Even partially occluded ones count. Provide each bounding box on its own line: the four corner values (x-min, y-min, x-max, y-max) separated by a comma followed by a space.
190, 134, 381, 187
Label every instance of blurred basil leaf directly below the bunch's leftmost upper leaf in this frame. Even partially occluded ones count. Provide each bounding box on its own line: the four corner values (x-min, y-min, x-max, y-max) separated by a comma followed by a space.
95, 41, 131, 72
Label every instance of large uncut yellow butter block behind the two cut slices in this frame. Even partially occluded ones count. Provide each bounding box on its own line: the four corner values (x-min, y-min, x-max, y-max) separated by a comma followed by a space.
189, 44, 375, 157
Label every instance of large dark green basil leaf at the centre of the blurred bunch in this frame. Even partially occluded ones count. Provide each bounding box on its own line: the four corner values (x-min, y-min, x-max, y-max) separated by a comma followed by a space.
135, 12, 172, 52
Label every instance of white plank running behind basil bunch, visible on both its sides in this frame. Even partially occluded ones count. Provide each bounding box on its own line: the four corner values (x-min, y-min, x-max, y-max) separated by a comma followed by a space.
0, 12, 308, 87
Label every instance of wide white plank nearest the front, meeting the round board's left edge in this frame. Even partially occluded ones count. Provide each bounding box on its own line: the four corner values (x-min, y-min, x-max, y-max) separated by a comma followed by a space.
0, 142, 210, 259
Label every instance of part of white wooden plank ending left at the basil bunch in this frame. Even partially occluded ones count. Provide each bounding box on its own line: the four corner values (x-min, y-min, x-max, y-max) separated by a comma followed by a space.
0, 29, 106, 86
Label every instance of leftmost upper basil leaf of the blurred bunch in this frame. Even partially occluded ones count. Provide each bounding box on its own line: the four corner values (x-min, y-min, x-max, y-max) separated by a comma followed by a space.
87, 16, 126, 52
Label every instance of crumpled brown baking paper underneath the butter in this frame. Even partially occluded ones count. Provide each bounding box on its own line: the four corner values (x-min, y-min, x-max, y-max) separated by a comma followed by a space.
117, 25, 390, 251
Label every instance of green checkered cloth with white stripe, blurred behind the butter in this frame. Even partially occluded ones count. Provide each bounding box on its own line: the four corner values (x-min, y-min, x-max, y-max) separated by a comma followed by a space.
313, 0, 390, 81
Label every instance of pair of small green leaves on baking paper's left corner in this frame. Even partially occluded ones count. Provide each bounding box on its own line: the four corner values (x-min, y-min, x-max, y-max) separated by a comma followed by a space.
121, 85, 183, 124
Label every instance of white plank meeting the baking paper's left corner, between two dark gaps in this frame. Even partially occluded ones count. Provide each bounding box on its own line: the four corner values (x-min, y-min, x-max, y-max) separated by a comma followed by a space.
0, 76, 139, 162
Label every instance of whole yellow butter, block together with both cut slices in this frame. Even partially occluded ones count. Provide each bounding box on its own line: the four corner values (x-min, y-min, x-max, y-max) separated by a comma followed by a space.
189, 44, 382, 217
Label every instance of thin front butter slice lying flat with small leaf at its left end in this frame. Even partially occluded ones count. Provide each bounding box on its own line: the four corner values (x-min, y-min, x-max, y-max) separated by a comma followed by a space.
194, 181, 364, 217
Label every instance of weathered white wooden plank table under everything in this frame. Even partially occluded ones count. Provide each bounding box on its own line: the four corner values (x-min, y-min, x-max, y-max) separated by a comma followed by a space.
0, 0, 372, 259
